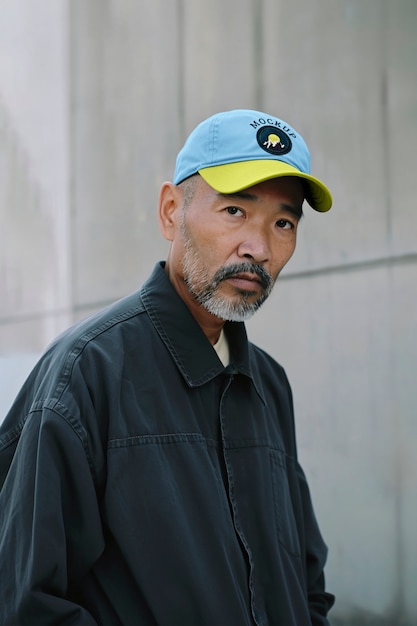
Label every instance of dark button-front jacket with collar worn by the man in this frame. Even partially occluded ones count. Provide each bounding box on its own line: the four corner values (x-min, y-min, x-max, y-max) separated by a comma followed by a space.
0, 264, 333, 626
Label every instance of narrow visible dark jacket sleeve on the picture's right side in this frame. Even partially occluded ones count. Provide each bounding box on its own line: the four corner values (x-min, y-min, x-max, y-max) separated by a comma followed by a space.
298, 465, 335, 626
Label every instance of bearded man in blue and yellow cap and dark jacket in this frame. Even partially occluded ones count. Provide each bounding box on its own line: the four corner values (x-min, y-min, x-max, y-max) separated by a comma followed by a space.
0, 110, 333, 626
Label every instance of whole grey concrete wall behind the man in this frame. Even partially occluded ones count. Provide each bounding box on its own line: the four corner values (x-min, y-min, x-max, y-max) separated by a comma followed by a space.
0, 0, 417, 626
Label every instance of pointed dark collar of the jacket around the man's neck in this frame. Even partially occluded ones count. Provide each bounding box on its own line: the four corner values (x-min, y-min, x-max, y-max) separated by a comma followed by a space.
140, 262, 262, 397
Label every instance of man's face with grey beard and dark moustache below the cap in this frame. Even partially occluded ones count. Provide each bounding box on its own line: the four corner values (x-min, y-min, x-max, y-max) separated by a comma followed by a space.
162, 177, 304, 321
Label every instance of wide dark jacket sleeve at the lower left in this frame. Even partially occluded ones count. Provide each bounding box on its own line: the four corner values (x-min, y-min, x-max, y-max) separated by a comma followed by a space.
0, 408, 104, 626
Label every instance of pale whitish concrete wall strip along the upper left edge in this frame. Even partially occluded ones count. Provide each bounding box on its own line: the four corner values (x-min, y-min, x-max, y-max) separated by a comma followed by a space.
0, 0, 72, 353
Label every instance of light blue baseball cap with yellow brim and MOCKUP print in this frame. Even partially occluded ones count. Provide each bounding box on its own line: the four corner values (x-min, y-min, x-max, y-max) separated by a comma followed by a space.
173, 109, 332, 213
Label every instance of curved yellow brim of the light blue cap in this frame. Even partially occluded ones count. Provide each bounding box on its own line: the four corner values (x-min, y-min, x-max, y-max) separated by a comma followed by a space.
198, 159, 333, 213
